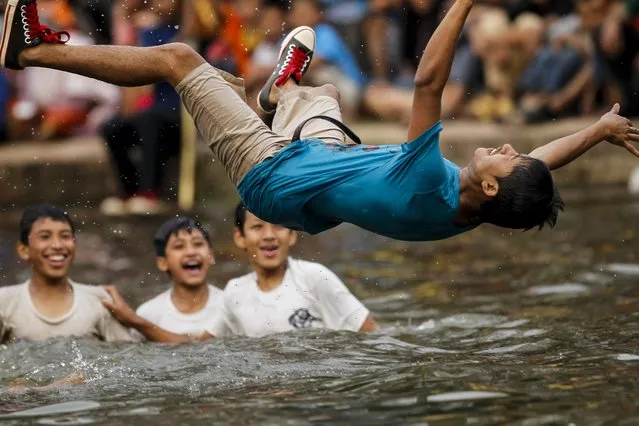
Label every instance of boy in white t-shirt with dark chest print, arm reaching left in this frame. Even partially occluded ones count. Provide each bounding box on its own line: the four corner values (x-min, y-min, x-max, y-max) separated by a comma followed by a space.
104, 204, 377, 343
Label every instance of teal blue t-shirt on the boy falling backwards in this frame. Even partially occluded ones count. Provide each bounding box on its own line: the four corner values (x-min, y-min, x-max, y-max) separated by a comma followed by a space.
238, 123, 471, 241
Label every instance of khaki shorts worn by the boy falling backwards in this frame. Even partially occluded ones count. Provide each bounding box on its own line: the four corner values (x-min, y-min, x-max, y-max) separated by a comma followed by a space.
175, 64, 346, 186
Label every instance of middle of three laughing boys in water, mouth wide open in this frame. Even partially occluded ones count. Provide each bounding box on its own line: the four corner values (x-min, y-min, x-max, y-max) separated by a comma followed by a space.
136, 217, 222, 336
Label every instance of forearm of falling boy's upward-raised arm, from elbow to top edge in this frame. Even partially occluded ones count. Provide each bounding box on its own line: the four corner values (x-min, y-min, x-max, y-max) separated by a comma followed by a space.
415, 0, 474, 90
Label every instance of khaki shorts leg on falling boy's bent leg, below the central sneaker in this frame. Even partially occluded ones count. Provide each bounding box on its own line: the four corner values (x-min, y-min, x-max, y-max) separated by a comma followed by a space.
272, 84, 346, 144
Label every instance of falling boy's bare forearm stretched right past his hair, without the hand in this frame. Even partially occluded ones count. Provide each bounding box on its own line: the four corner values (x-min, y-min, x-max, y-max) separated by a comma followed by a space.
530, 121, 607, 170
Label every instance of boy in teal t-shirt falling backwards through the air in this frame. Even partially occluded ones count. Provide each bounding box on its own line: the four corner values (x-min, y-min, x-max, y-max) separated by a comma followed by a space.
5, 0, 639, 241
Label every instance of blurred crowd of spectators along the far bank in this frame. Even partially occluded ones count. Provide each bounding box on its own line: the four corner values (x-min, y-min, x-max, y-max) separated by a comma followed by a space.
0, 0, 639, 215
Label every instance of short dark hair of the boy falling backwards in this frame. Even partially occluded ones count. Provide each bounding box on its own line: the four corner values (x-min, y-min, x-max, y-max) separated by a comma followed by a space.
479, 156, 564, 231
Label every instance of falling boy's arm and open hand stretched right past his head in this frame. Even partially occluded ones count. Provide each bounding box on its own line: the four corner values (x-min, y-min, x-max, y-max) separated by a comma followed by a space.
530, 104, 639, 170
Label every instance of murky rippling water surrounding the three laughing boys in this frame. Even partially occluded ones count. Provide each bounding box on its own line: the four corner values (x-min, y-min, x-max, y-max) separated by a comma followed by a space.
0, 192, 639, 426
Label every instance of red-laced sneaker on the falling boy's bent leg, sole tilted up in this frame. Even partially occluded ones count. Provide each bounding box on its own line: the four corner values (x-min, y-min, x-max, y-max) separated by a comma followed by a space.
257, 27, 315, 114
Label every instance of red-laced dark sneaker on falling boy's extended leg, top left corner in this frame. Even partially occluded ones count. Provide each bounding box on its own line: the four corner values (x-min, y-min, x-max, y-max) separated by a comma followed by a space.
0, 0, 69, 70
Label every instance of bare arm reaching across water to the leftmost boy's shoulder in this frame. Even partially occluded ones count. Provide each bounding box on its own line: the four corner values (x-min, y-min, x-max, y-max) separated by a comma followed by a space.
102, 287, 213, 343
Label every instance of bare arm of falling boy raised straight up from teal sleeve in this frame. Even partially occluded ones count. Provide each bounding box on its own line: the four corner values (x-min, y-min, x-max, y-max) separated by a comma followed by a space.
408, 0, 474, 141
